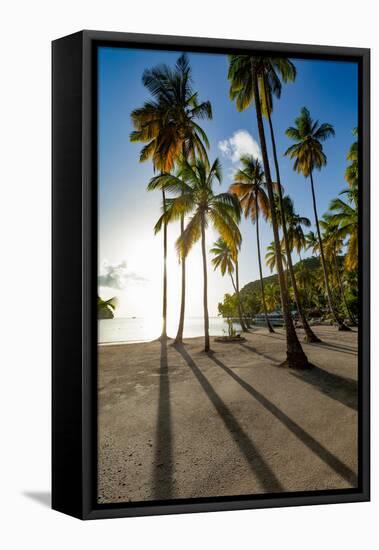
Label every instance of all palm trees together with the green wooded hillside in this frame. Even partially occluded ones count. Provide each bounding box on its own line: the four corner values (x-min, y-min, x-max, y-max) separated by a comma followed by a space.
130, 54, 359, 369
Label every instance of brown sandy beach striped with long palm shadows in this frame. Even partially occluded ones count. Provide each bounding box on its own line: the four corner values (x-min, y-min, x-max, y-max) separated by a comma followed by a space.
98, 327, 358, 503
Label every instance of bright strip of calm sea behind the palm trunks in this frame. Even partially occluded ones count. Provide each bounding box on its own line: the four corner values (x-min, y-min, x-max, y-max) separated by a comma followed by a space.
98, 317, 240, 344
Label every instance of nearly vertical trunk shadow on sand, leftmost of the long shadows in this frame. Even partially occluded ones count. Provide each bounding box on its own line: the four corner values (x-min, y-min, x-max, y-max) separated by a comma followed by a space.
153, 339, 172, 500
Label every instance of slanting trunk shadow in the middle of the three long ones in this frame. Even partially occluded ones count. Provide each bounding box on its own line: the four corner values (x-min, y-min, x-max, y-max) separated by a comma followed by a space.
176, 346, 283, 493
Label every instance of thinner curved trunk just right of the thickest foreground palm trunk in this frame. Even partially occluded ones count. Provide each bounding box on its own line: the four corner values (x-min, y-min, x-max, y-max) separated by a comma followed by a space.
265, 86, 321, 342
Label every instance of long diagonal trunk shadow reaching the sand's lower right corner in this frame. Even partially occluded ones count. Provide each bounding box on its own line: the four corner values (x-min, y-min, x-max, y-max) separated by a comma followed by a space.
209, 354, 358, 487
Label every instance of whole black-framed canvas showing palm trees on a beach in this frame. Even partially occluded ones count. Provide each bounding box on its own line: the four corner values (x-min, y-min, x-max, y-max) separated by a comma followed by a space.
52, 31, 370, 519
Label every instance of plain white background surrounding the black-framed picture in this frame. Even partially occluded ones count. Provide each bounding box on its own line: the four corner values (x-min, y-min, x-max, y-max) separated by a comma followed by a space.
0, 0, 379, 550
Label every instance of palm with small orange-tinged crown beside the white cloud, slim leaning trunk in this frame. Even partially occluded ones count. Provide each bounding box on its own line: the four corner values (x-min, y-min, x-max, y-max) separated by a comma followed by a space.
229, 155, 274, 332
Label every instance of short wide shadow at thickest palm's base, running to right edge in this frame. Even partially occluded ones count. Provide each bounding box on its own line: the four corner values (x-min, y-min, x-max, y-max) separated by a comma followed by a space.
291, 365, 358, 410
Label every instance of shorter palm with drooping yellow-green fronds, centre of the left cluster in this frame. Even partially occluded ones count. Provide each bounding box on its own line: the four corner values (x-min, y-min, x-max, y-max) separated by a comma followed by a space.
149, 159, 241, 352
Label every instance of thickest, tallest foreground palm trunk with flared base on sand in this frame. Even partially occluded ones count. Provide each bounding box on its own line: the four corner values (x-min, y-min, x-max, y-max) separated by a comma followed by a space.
252, 67, 310, 369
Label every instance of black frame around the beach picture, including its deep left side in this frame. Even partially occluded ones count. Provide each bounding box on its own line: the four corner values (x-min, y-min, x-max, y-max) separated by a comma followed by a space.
52, 30, 370, 519
